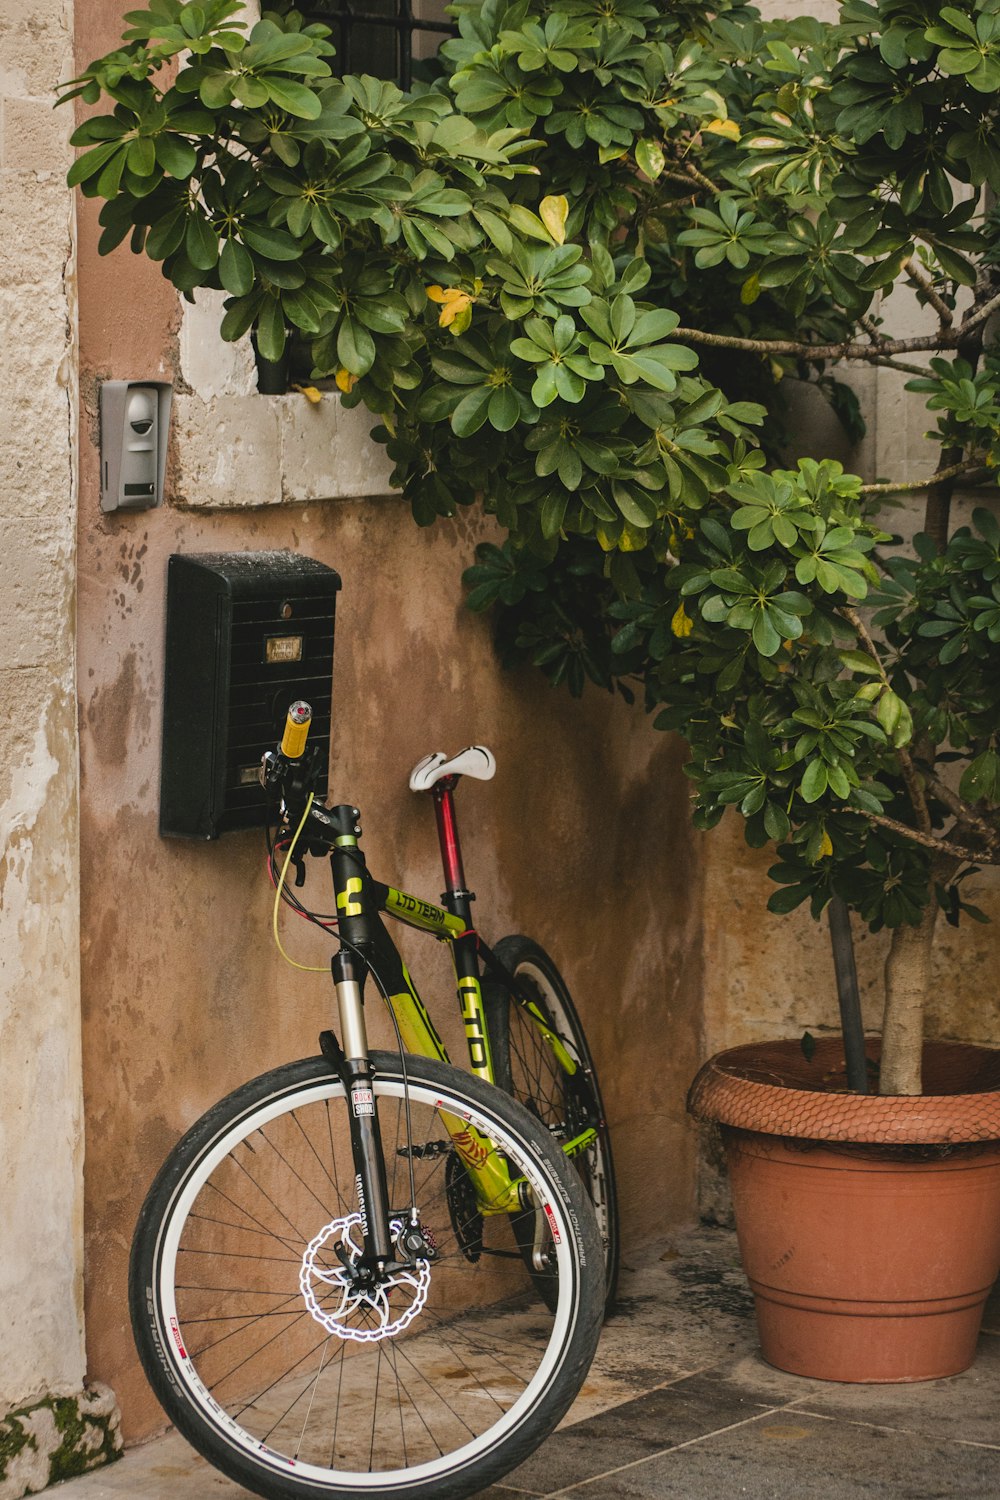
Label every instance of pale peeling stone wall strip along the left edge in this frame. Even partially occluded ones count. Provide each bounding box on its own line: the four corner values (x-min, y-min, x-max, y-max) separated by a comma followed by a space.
0, 0, 84, 1413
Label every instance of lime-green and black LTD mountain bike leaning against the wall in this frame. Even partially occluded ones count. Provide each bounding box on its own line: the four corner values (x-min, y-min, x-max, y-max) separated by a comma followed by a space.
129, 704, 610, 1500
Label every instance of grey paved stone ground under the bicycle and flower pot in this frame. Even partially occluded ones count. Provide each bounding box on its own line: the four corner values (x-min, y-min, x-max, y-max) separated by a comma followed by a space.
48, 1230, 1000, 1500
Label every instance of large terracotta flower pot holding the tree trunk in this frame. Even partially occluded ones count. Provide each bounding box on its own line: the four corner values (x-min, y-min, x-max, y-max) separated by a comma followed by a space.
688, 1040, 1000, 1382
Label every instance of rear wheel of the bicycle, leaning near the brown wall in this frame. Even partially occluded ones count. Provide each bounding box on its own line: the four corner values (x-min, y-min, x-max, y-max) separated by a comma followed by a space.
483, 936, 621, 1311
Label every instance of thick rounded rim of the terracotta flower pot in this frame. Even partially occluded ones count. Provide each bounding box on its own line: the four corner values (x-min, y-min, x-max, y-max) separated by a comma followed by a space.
687, 1037, 1000, 1146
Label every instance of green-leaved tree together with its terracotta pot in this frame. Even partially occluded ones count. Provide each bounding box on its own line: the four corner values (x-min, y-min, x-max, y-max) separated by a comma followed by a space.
66, 0, 1000, 1379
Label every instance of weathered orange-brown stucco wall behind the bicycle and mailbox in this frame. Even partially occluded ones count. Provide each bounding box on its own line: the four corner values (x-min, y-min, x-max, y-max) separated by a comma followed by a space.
78, 0, 700, 1437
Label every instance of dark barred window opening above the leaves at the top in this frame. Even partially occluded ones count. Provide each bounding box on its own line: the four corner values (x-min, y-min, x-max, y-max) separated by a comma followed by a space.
298, 0, 456, 89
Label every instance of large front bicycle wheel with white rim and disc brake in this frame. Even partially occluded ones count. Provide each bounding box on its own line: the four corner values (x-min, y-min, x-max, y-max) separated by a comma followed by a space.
129, 1053, 601, 1500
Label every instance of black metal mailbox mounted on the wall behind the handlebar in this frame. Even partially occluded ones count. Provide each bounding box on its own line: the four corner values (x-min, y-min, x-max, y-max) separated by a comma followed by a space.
160, 552, 340, 839
